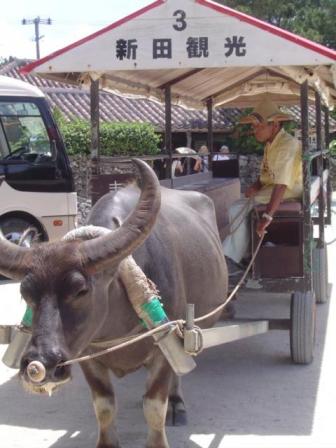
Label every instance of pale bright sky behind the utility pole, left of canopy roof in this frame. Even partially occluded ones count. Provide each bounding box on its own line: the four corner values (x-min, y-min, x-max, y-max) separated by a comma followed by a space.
0, 0, 152, 60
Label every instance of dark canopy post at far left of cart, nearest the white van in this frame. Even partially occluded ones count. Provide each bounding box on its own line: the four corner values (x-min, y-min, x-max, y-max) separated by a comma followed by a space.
90, 79, 100, 180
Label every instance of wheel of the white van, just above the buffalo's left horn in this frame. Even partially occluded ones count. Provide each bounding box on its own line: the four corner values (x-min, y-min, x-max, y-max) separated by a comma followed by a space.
0, 217, 43, 247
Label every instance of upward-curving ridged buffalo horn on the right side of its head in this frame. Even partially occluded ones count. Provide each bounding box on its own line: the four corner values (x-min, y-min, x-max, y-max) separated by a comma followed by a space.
80, 159, 161, 271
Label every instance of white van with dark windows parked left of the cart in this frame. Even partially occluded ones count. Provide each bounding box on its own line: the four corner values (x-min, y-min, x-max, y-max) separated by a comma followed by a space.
0, 76, 77, 243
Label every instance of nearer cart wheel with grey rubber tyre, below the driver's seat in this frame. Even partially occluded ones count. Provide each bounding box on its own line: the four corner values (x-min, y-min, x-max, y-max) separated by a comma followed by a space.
290, 291, 316, 364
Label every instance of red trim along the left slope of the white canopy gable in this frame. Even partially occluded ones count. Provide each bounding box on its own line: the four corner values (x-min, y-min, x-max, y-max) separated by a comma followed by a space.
20, 0, 165, 75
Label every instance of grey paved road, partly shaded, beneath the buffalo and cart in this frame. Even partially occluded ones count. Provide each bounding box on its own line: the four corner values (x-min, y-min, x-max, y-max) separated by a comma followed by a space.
0, 219, 336, 448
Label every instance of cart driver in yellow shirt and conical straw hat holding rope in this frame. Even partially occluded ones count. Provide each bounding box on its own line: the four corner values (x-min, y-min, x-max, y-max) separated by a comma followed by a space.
223, 97, 303, 271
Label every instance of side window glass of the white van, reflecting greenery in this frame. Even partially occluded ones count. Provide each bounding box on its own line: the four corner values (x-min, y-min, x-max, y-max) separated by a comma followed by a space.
0, 101, 52, 163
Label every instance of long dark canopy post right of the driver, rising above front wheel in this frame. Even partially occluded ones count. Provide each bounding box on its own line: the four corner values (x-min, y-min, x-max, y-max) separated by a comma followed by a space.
300, 81, 313, 293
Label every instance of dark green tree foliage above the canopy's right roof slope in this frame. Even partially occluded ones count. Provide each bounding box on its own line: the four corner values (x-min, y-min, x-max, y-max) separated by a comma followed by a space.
216, 0, 336, 48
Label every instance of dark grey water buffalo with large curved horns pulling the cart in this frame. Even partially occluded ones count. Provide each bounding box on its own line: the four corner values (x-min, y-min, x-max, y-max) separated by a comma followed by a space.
0, 160, 228, 448
